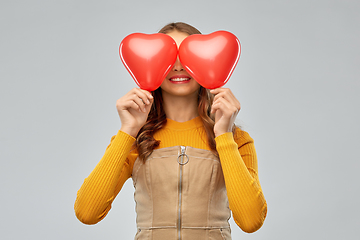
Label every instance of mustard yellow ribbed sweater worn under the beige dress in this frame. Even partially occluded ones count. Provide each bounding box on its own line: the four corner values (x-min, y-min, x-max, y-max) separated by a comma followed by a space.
75, 117, 267, 232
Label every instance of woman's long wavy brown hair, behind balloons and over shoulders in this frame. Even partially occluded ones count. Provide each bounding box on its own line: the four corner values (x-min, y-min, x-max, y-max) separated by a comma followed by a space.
135, 22, 235, 161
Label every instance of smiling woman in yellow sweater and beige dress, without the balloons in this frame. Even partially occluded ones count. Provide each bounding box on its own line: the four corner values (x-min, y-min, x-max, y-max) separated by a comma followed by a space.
75, 23, 267, 240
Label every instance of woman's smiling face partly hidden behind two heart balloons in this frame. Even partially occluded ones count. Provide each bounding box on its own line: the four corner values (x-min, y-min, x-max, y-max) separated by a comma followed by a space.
161, 31, 200, 96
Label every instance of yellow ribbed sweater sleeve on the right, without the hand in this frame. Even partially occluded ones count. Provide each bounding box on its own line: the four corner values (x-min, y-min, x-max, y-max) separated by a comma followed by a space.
215, 129, 267, 233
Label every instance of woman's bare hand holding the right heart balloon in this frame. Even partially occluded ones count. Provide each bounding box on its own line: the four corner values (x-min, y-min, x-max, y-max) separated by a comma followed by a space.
210, 88, 241, 137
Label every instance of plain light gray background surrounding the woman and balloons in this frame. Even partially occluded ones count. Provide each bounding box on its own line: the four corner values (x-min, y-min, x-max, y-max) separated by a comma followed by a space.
0, 0, 360, 240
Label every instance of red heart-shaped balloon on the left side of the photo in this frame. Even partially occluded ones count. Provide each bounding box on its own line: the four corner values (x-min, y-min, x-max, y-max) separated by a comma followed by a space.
119, 33, 178, 91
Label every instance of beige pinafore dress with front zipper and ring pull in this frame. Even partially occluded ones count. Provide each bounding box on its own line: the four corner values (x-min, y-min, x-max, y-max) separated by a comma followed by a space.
132, 146, 231, 240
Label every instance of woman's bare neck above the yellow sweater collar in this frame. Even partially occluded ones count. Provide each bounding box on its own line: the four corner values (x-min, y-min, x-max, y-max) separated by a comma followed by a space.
162, 91, 199, 122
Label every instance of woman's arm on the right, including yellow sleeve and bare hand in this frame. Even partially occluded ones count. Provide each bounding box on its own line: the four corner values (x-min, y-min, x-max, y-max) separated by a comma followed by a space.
210, 88, 267, 232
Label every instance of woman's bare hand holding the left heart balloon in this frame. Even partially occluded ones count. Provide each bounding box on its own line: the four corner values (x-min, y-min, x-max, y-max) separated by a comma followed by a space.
116, 88, 154, 137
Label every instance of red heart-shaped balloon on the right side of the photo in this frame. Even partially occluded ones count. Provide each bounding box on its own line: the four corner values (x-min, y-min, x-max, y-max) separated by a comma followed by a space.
179, 31, 241, 89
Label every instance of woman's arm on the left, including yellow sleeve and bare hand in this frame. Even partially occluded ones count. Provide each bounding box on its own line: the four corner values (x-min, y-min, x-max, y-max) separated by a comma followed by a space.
74, 88, 153, 224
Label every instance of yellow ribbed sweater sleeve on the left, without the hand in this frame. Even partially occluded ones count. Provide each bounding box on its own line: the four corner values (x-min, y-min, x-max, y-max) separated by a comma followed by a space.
74, 131, 135, 224
